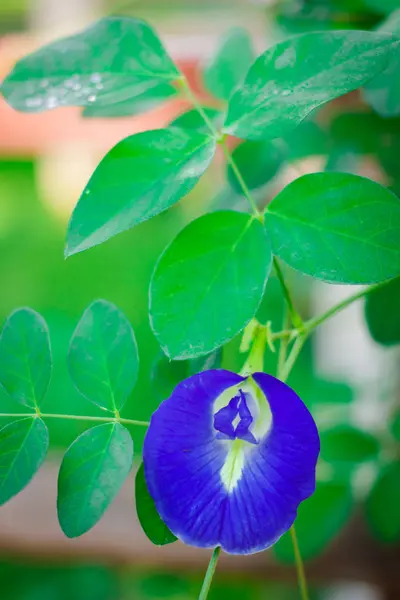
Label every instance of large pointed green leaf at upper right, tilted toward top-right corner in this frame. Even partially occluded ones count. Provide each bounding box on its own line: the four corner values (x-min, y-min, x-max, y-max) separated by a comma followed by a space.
224, 31, 398, 140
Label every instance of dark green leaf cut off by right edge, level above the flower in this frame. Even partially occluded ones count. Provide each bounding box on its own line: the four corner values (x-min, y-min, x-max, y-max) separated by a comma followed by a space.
365, 277, 400, 346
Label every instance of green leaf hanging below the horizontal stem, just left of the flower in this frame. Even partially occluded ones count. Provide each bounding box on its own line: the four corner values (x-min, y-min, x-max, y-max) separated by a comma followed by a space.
57, 422, 133, 538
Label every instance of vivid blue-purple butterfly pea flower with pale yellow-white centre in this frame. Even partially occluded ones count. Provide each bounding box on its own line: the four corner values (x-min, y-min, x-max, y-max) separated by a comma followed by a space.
143, 370, 319, 554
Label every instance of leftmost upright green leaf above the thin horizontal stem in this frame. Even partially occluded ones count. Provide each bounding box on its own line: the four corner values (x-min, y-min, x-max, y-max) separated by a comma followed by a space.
0, 308, 52, 408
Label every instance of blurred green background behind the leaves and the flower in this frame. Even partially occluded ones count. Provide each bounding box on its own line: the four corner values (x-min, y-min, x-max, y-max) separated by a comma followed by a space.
0, 0, 400, 600
